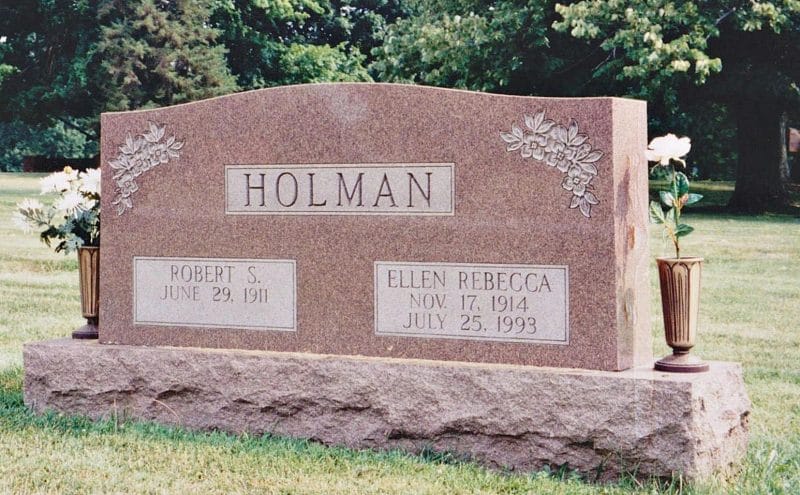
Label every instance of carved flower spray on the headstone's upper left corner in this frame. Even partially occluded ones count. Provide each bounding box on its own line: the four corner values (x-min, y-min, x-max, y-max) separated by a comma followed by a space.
108, 122, 183, 215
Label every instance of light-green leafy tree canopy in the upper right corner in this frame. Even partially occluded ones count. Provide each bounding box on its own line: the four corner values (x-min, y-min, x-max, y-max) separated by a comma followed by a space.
554, 0, 800, 108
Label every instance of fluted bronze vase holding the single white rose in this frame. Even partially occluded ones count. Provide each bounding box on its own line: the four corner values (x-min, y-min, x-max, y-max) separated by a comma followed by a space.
655, 258, 708, 373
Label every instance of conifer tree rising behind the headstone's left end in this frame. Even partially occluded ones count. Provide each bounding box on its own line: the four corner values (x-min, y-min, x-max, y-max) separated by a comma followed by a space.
87, 0, 238, 112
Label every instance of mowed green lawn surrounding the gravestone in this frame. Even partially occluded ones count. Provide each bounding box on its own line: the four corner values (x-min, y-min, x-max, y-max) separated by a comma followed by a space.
0, 174, 800, 494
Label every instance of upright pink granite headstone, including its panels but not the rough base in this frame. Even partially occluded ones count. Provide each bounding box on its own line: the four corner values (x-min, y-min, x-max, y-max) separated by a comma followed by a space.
100, 84, 652, 370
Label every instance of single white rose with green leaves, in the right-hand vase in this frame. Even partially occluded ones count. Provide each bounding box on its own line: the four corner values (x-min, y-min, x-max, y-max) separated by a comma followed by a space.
645, 134, 703, 258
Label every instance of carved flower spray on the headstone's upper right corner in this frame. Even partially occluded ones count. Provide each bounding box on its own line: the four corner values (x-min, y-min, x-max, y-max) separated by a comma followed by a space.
500, 110, 603, 218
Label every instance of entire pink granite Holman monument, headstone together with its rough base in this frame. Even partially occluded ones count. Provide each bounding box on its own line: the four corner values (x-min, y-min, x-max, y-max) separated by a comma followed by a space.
24, 84, 750, 480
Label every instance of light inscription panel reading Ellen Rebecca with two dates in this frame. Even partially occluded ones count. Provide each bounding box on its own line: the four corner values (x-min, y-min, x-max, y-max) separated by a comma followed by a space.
374, 261, 569, 344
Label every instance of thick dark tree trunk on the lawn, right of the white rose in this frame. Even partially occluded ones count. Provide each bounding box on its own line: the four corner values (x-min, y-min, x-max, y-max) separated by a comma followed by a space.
728, 100, 790, 213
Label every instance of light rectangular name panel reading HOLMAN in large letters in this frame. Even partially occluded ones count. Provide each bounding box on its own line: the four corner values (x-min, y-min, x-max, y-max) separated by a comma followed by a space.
225, 163, 454, 215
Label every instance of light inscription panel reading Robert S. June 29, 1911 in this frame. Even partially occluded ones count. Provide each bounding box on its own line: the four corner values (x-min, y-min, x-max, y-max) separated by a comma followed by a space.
133, 256, 297, 331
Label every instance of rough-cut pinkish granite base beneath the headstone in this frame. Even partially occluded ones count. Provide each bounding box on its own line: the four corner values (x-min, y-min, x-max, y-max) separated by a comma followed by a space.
24, 340, 750, 480
